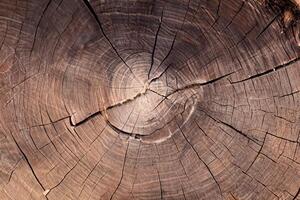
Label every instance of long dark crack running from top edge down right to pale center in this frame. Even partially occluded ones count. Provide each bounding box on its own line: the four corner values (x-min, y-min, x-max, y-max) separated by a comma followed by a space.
83, 0, 141, 83
